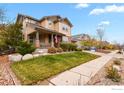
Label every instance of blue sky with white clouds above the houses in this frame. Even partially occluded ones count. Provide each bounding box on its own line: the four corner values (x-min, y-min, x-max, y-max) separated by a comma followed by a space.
0, 3, 124, 43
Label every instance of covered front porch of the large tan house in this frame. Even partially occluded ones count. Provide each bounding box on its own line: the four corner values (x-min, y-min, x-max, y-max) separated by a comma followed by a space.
27, 28, 64, 48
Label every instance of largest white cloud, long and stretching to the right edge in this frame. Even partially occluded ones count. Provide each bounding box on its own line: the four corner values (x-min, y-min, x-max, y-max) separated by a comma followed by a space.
89, 5, 124, 15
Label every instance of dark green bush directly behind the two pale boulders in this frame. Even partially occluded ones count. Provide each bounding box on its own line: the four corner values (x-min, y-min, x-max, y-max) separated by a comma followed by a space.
16, 41, 35, 55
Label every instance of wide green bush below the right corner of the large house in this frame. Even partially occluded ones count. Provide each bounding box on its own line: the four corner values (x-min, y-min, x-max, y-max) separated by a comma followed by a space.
60, 43, 77, 51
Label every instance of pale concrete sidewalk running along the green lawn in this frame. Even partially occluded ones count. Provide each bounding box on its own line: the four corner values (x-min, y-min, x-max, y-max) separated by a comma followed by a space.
48, 51, 117, 85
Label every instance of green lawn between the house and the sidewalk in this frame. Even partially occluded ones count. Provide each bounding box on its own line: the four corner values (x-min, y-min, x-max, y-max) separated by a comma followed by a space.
11, 52, 98, 84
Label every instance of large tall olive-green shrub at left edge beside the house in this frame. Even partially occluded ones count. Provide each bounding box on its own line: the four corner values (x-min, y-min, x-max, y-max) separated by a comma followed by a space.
0, 23, 23, 48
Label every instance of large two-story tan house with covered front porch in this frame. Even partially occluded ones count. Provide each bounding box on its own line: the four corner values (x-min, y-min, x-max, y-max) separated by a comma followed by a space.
16, 14, 72, 48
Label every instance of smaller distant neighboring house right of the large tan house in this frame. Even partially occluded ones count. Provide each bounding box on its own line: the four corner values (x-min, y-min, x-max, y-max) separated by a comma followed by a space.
71, 34, 91, 48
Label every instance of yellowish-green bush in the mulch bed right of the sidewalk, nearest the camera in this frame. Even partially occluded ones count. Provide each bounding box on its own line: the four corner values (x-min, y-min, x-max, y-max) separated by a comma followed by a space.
107, 66, 121, 82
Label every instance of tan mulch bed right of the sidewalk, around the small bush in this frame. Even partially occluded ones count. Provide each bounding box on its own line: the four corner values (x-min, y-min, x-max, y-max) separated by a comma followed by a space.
88, 59, 124, 85
